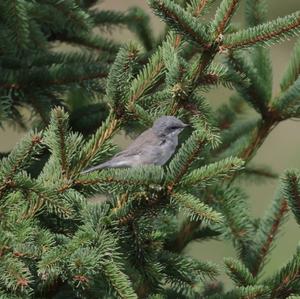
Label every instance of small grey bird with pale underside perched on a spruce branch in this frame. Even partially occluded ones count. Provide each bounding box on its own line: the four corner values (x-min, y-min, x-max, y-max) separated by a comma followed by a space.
82, 116, 187, 174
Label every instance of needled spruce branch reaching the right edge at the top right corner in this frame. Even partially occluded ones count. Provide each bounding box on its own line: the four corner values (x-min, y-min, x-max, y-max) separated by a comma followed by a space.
223, 11, 300, 50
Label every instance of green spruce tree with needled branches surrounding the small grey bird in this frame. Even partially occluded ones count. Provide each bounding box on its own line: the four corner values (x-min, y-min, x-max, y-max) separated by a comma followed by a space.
0, 0, 300, 299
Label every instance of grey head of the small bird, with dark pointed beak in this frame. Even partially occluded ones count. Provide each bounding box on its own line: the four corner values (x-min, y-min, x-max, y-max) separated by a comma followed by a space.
152, 116, 188, 137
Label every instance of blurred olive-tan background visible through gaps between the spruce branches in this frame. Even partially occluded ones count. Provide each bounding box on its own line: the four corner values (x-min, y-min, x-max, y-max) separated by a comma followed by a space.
0, 0, 300, 285
